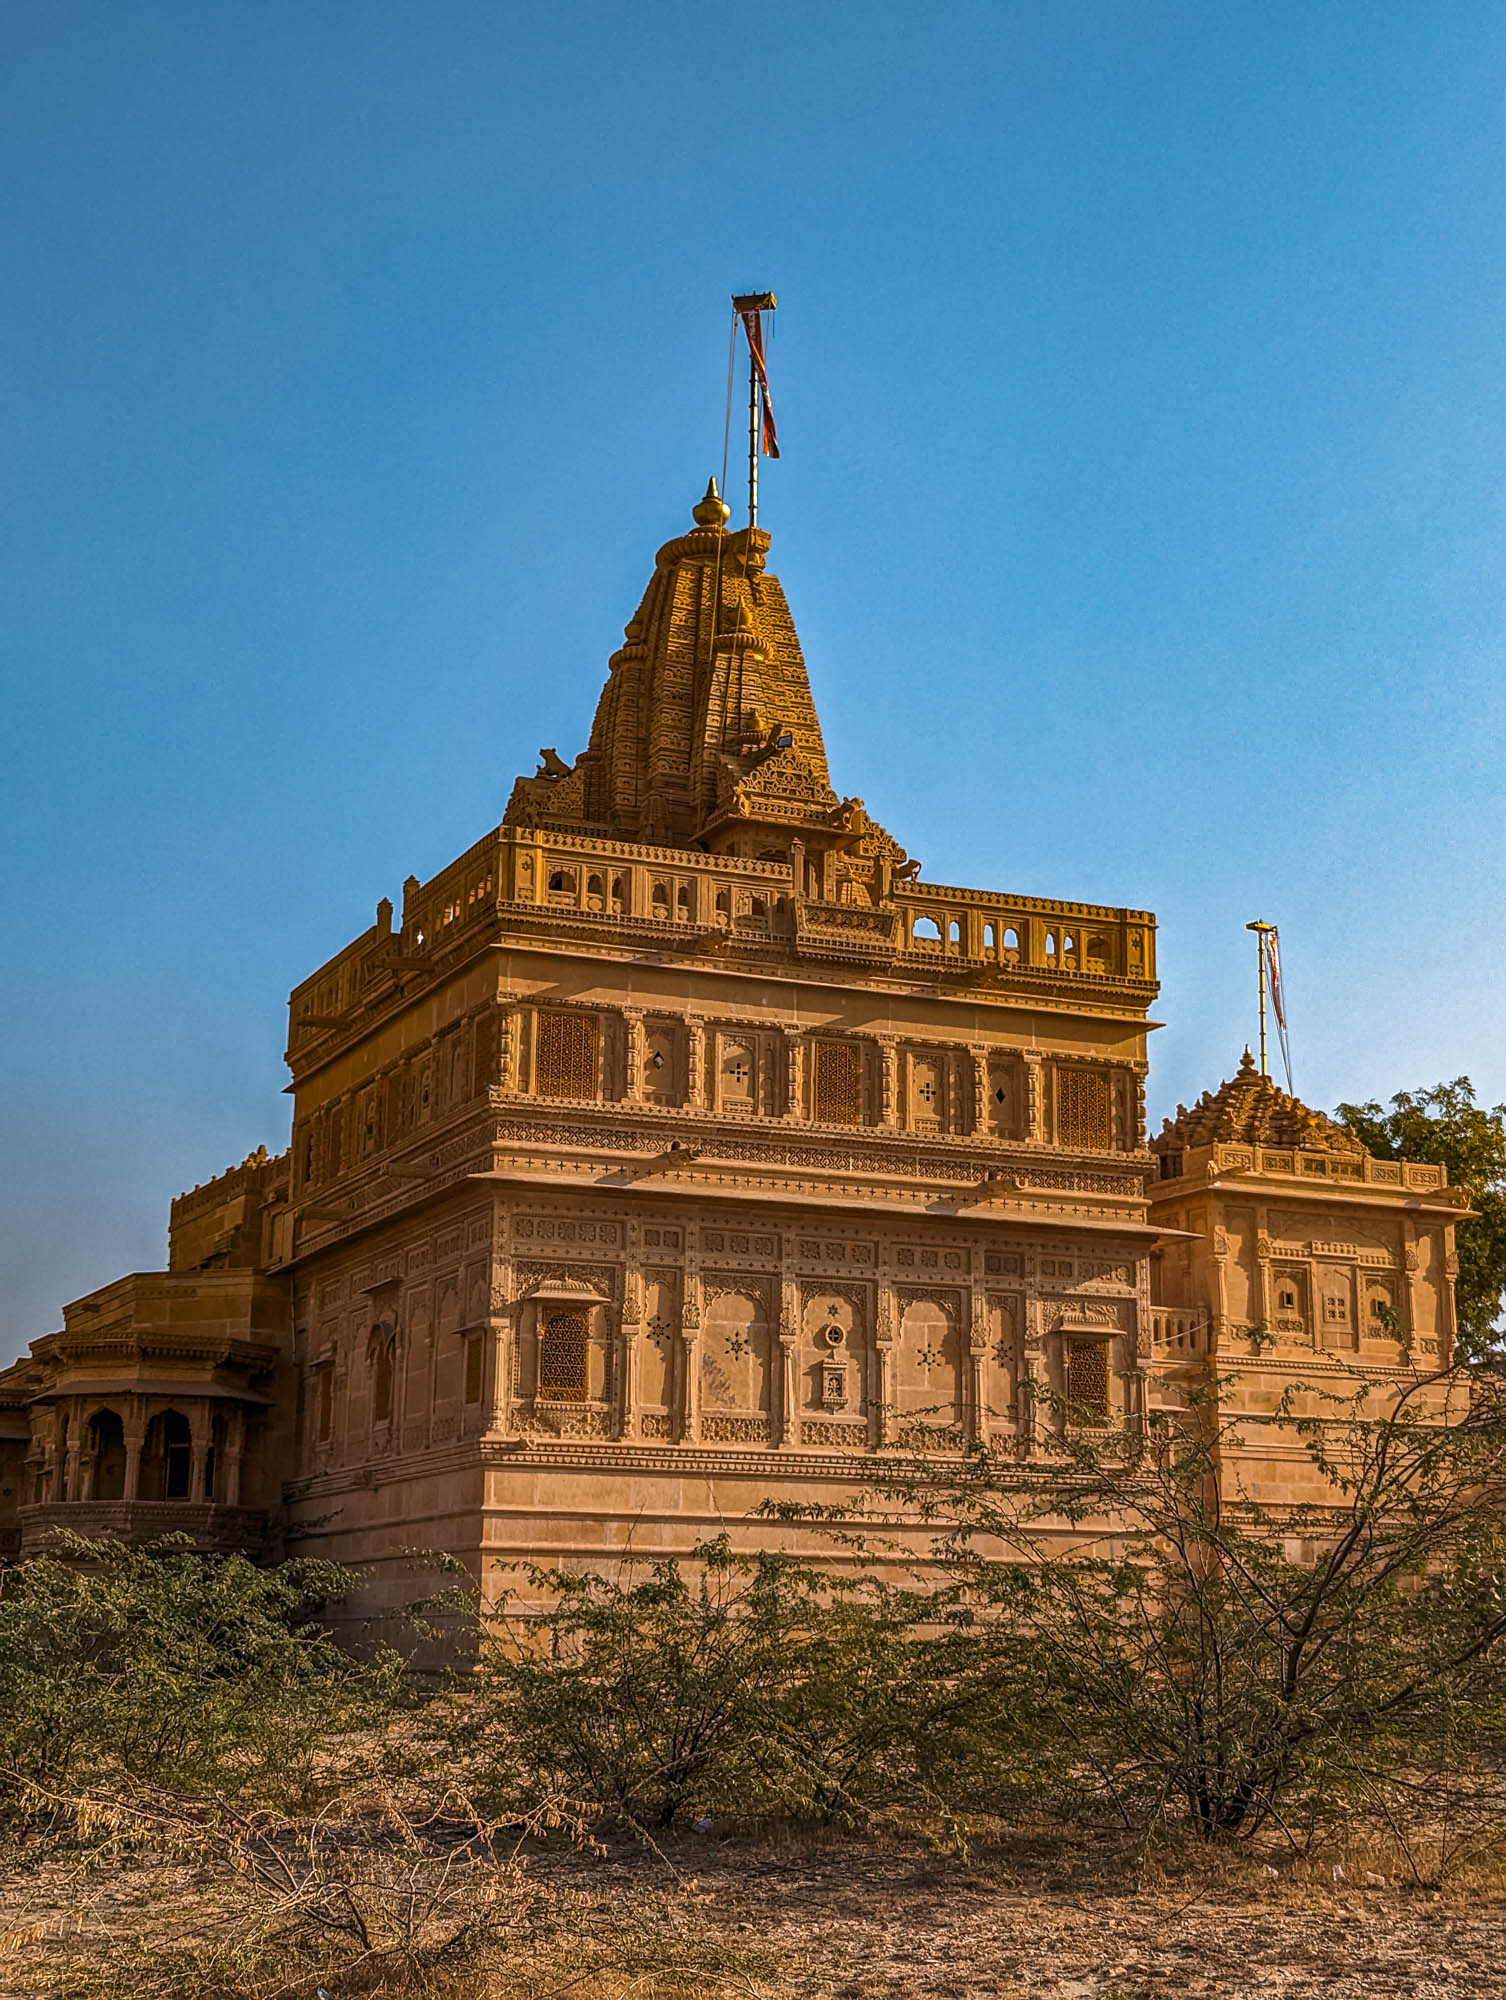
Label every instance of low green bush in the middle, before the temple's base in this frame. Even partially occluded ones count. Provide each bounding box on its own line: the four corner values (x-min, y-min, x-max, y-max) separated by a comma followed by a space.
422, 1536, 958, 1830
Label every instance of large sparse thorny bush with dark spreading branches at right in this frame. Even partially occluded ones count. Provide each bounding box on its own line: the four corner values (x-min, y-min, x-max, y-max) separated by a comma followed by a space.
880, 1370, 1506, 1842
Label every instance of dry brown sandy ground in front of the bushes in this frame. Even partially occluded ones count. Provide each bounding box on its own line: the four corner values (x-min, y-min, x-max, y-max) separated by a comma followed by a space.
0, 1828, 1506, 2000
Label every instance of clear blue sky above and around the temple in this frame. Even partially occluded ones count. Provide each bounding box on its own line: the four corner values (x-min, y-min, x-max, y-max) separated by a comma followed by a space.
0, 0, 1506, 1358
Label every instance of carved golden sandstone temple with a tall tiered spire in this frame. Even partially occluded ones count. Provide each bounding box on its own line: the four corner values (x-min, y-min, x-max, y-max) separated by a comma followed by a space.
0, 476, 1466, 1604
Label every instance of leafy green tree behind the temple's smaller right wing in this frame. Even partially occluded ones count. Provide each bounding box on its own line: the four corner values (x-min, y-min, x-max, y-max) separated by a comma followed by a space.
1338, 1076, 1506, 1360
